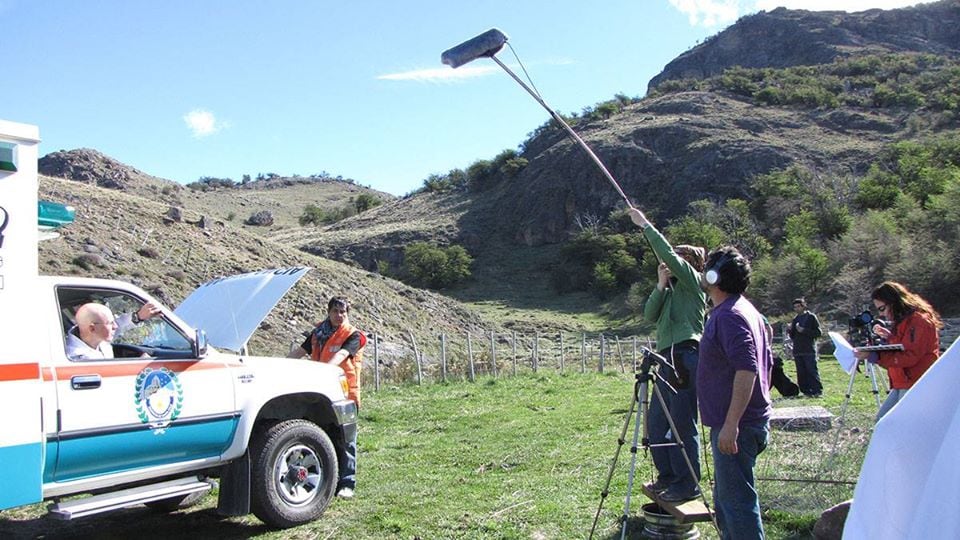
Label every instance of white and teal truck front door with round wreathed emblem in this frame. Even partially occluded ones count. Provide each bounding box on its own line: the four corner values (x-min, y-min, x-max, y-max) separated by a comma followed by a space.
53, 286, 239, 482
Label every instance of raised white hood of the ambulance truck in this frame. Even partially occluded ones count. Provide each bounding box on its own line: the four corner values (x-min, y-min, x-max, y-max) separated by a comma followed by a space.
174, 266, 310, 351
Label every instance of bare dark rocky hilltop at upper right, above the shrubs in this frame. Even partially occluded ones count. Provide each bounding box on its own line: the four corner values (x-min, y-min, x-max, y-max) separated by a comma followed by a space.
649, 0, 960, 89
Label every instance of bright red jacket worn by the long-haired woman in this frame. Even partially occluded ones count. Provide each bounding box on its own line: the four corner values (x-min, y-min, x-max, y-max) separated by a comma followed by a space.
877, 311, 940, 390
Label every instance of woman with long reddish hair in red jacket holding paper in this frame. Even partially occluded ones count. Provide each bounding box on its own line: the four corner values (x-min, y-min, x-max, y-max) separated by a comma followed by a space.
854, 281, 943, 421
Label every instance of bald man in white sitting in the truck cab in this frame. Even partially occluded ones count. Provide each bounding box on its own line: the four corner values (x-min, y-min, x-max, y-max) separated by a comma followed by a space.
67, 302, 160, 360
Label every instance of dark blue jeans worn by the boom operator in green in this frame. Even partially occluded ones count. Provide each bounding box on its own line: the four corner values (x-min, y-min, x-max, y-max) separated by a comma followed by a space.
647, 345, 700, 493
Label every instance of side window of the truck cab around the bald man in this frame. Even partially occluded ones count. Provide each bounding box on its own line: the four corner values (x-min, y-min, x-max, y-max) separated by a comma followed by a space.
57, 287, 193, 360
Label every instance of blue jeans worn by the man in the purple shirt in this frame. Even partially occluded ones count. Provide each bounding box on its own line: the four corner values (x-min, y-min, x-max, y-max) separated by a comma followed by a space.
710, 423, 770, 540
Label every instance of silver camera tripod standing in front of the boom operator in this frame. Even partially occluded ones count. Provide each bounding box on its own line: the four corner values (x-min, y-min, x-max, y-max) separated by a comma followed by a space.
590, 347, 720, 540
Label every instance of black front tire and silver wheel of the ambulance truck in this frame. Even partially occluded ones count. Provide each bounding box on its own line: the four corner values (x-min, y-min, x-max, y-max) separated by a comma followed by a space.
250, 419, 337, 528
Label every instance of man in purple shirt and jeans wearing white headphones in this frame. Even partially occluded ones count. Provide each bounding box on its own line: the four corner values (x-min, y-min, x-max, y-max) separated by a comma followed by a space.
697, 246, 773, 540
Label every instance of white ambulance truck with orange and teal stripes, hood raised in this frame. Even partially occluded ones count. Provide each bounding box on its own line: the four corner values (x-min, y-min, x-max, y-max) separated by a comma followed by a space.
0, 120, 357, 527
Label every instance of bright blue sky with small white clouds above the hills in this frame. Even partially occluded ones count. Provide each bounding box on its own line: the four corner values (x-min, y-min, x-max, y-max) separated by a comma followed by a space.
0, 0, 936, 195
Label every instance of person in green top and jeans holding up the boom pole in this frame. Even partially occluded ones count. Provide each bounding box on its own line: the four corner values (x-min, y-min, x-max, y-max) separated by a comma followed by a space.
630, 208, 707, 502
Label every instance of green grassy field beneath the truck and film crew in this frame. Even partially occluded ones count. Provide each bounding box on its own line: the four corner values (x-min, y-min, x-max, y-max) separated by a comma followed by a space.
0, 358, 876, 539
